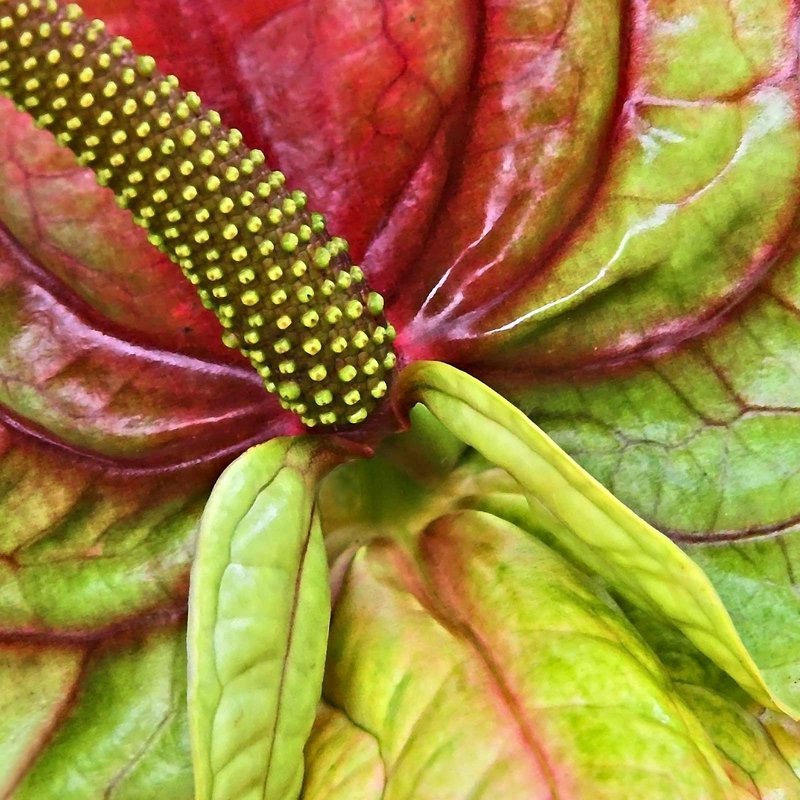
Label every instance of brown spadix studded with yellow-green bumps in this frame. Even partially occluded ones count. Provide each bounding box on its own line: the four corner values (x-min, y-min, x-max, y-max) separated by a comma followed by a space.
0, 0, 395, 427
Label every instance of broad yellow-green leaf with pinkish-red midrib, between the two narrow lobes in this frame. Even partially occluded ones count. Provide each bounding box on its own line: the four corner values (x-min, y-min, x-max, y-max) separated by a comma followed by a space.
322, 511, 730, 800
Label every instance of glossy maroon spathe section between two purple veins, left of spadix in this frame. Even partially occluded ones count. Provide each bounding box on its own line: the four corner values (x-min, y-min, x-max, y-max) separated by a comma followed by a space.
0, 219, 292, 463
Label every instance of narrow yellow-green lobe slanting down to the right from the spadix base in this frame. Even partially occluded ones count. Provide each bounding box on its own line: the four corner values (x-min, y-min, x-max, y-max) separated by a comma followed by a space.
397, 362, 796, 716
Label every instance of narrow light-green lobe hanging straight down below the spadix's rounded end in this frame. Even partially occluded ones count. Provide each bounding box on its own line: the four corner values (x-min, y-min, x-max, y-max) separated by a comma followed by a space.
189, 439, 344, 800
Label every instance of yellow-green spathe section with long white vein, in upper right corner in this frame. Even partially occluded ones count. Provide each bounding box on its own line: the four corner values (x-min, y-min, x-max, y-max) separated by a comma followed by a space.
405, 0, 800, 369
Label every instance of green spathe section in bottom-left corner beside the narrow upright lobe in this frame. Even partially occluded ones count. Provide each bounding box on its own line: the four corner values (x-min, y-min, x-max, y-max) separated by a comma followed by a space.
11, 626, 192, 800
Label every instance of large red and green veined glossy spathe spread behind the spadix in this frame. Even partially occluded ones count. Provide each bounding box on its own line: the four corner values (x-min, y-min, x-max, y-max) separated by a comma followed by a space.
0, 0, 800, 797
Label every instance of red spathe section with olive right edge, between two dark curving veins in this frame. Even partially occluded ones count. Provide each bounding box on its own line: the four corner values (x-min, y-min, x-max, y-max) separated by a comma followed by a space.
396, 0, 625, 334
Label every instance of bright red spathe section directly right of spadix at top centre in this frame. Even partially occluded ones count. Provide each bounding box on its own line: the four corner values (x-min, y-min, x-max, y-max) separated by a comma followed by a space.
223, 0, 480, 268
